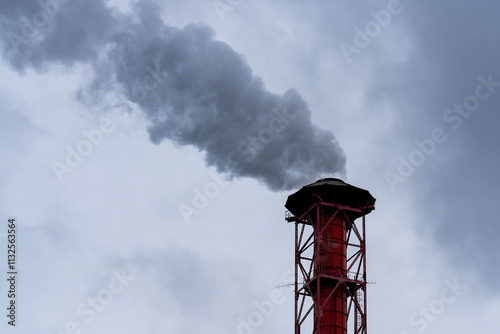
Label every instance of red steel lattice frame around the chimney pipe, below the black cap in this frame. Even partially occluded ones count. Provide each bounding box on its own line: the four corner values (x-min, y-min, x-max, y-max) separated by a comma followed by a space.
286, 201, 367, 334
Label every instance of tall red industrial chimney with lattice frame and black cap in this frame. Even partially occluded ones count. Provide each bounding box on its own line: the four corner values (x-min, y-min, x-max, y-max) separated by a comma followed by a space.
285, 178, 375, 334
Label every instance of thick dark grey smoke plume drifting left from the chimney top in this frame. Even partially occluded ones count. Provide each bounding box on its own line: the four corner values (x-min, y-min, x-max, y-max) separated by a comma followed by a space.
0, 0, 345, 190
